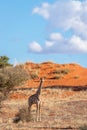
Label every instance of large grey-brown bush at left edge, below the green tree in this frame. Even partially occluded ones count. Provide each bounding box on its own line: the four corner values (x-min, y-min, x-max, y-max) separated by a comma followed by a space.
0, 65, 29, 104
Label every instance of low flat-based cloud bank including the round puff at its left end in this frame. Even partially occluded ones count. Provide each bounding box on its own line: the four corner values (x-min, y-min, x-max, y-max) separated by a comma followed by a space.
29, 33, 87, 54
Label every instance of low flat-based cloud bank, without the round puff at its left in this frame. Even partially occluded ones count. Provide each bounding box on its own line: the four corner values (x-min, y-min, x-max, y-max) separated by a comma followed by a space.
43, 33, 87, 53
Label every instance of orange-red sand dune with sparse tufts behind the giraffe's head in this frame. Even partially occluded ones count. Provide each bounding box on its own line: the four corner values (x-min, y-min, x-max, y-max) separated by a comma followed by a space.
18, 62, 87, 87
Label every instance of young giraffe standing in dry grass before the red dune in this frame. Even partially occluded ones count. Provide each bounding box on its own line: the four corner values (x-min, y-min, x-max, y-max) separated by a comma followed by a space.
28, 78, 44, 121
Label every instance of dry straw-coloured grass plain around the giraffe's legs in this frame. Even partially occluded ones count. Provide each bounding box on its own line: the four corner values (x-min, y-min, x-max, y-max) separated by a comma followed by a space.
0, 89, 87, 130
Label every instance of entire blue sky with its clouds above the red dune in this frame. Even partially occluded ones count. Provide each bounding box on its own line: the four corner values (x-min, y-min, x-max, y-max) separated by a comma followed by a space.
0, 0, 87, 67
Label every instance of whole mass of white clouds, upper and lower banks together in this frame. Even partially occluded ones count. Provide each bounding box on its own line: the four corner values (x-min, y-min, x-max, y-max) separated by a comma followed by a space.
30, 0, 87, 53
